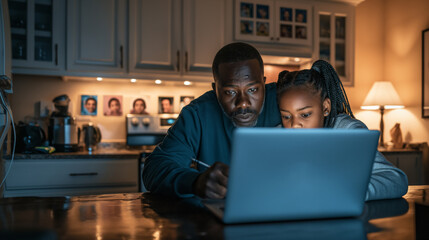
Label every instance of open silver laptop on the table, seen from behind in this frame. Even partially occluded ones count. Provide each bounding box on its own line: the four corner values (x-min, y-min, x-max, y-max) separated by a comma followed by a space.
203, 128, 379, 223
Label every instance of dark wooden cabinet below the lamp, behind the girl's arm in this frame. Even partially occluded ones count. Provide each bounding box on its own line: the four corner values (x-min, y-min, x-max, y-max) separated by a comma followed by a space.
380, 150, 424, 185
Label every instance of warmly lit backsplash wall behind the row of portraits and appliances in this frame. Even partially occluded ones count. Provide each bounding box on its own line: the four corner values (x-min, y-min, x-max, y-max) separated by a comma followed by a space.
10, 65, 297, 142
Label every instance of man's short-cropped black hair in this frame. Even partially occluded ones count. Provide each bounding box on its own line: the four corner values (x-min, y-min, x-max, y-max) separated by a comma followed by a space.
212, 42, 264, 80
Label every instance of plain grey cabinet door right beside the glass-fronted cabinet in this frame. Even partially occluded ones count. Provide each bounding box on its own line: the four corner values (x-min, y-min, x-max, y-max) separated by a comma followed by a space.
67, 0, 127, 74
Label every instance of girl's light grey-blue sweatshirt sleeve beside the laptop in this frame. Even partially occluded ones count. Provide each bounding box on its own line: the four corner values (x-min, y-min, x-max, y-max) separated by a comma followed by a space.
333, 114, 408, 201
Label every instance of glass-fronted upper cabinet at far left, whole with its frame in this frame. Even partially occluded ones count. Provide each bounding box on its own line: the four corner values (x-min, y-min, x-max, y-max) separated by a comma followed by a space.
8, 0, 65, 74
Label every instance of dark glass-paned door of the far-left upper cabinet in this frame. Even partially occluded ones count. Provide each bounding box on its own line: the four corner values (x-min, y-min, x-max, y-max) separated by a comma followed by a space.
8, 0, 64, 69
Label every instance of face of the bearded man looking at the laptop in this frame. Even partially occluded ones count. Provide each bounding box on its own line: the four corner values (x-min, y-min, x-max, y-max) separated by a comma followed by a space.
213, 59, 265, 127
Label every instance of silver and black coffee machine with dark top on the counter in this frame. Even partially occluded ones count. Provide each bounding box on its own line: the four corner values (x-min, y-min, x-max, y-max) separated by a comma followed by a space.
48, 95, 80, 152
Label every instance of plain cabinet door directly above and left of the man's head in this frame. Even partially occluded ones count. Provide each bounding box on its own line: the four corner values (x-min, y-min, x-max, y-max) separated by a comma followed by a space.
182, 0, 225, 76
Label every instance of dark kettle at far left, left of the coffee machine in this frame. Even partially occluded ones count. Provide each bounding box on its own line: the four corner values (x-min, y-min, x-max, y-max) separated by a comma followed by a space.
15, 122, 46, 153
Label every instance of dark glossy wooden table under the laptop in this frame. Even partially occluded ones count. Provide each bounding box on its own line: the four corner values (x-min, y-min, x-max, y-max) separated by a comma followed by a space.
0, 186, 429, 239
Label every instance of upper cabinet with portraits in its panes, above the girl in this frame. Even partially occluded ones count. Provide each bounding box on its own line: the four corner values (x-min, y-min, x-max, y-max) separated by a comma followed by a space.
234, 0, 313, 45
